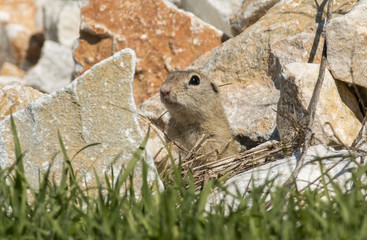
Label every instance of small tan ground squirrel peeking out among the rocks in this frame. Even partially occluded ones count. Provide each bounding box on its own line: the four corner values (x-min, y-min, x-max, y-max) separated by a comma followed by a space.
160, 71, 237, 160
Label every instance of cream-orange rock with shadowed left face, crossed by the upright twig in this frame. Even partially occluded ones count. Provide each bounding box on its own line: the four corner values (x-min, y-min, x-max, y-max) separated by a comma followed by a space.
277, 63, 361, 146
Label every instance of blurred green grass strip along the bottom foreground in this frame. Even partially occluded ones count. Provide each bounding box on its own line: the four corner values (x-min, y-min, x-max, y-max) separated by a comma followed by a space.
0, 116, 367, 239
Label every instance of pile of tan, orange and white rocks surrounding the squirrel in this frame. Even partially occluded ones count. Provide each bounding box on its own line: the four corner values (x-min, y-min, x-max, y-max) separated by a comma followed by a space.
0, 0, 367, 195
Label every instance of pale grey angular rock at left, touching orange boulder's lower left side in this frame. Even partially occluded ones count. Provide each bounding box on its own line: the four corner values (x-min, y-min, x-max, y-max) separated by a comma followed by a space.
24, 41, 74, 93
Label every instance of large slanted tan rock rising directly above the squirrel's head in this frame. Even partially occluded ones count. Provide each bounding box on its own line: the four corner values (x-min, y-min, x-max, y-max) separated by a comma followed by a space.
190, 0, 356, 88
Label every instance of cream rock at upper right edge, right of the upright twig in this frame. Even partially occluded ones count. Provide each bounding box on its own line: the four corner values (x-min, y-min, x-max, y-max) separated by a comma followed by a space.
326, 0, 367, 88
